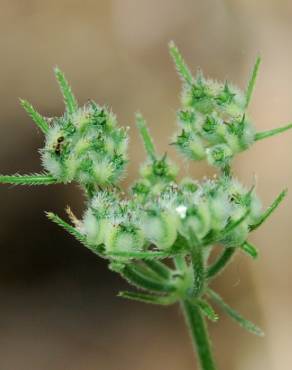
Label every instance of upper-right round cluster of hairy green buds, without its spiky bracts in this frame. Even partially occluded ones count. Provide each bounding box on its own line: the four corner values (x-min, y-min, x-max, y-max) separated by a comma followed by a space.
174, 72, 255, 167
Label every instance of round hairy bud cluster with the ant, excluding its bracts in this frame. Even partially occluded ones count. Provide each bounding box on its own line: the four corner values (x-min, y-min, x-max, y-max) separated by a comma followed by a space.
41, 102, 128, 189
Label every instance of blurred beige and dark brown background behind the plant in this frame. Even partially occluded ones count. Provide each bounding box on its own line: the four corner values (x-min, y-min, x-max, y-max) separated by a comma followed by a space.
0, 0, 292, 370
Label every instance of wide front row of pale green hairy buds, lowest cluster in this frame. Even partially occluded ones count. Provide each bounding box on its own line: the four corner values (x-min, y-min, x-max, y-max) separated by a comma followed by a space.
80, 177, 262, 256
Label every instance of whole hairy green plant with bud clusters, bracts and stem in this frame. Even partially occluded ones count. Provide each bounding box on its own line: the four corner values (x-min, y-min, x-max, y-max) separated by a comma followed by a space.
0, 43, 292, 370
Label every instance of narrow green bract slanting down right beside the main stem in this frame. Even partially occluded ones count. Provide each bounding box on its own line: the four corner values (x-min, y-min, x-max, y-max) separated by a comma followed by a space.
207, 289, 264, 337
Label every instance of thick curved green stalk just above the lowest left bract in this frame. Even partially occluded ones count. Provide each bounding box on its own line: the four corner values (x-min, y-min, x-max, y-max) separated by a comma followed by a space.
121, 264, 176, 293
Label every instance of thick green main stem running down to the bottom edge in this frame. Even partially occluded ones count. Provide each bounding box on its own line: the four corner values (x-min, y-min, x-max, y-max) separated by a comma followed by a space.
181, 300, 216, 370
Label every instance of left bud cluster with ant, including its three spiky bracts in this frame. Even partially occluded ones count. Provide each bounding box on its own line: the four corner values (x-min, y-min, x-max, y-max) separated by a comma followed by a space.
6, 68, 128, 197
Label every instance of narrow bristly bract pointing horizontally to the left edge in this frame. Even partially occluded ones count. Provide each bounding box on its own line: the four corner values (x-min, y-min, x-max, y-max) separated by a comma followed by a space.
0, 173, 59, 185
